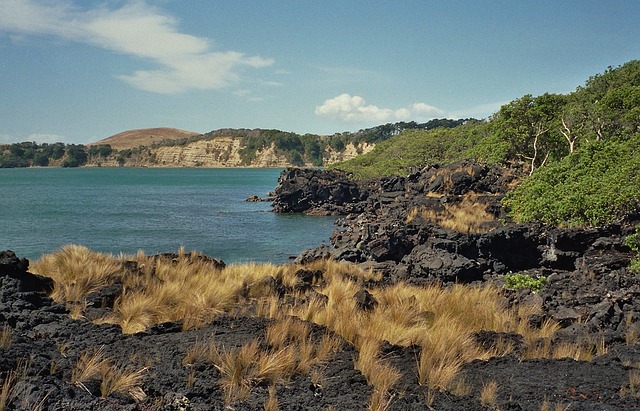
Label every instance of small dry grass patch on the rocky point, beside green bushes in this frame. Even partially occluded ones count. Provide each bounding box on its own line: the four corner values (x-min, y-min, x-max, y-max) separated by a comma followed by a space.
405, 193, 495, 233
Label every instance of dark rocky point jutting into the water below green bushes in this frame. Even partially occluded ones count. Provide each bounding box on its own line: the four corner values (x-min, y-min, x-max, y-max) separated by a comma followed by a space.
273, 160, 640, 343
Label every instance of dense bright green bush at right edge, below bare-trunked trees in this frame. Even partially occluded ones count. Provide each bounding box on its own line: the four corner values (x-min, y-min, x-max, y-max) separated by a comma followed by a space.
503, 134, 640, 226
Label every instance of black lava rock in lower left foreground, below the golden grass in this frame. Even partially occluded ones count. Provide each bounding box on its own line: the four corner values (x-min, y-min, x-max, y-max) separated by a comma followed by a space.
0, 251, 372, 411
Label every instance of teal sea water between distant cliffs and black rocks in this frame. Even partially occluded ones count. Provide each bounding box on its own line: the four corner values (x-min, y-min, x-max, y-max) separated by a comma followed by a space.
0, 168, 334, 263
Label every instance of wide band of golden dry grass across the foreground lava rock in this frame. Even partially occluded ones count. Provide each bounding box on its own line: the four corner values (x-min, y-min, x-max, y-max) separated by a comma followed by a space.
35, 246, 586, 409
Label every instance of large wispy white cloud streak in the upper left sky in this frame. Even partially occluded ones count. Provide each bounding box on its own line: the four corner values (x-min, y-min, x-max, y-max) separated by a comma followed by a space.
0, 0, 273, 94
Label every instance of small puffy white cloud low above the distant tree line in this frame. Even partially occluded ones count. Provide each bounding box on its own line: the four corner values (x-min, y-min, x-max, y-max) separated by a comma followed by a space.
315, 93, 445, 122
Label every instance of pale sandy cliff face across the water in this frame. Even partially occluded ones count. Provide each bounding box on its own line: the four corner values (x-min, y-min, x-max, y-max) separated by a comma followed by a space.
87, 137, 375, 168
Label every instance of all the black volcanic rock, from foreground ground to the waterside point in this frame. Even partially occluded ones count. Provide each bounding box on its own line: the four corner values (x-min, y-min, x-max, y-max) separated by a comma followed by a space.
0, 163, 640, 410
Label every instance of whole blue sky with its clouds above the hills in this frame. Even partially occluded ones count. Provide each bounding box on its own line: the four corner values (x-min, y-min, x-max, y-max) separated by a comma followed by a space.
0, 0, 640, 143
